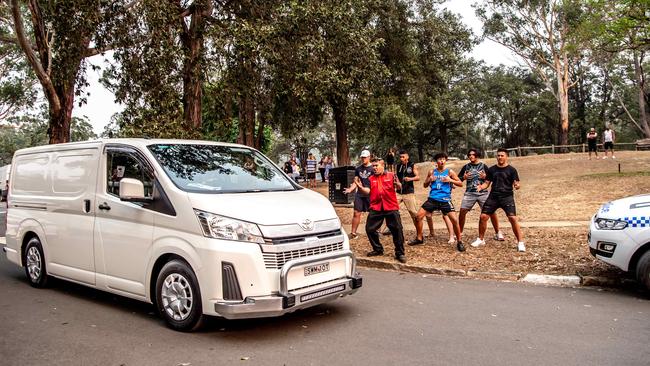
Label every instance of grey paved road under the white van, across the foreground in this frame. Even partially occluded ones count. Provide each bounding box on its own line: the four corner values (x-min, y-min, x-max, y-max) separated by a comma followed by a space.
0, 249, 650, 366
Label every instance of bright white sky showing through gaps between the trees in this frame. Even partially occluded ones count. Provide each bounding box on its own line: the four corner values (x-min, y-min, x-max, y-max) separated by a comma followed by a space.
72, 0, 517, 135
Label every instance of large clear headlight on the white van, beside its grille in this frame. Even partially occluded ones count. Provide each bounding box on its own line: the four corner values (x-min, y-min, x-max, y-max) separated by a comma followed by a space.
194, 209, 264, 244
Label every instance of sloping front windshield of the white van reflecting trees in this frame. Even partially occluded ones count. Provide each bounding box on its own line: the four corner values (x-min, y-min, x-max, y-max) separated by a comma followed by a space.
148, 144, 297, 193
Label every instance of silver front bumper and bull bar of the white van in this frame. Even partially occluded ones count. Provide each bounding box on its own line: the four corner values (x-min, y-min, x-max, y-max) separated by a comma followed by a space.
214, 251, 363, 319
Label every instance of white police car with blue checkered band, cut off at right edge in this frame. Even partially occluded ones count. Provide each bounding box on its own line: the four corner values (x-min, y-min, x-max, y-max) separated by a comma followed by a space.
589, 194, 650, 290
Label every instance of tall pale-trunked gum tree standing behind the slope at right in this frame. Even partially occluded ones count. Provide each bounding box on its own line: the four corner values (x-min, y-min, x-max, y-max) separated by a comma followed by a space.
476, 0, 583, 145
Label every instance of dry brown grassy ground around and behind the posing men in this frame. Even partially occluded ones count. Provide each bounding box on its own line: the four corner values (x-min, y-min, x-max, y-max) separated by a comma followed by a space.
306, 151, 650, 277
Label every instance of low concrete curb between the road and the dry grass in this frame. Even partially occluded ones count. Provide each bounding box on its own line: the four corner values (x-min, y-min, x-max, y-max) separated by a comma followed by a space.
357, 258, 625, 287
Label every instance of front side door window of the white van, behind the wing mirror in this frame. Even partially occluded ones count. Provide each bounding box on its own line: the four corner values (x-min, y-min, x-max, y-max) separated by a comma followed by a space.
106, 150, 153, 197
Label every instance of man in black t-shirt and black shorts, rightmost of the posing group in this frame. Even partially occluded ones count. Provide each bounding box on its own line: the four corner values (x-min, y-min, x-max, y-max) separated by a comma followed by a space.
471, 148, 526, 252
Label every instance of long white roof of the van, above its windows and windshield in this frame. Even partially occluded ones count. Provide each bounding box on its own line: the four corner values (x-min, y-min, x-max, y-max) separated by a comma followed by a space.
16, 138, 252, 155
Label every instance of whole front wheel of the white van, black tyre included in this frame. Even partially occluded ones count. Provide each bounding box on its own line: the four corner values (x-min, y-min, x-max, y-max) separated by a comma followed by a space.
156, 260, 204, 332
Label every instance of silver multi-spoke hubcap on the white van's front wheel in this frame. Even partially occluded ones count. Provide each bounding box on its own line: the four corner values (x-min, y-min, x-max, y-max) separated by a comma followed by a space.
161, 273, 194, 320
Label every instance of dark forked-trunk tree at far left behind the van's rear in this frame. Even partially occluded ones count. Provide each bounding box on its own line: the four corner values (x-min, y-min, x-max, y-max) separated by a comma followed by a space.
0, 0, 130, 143
